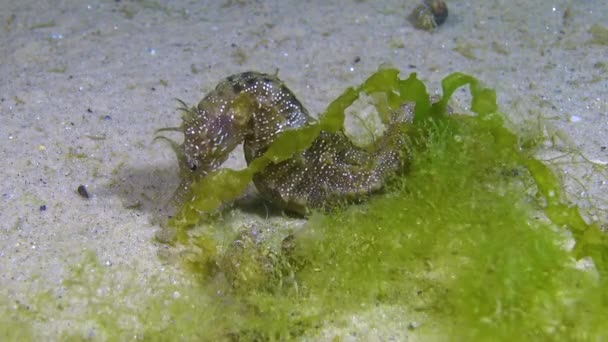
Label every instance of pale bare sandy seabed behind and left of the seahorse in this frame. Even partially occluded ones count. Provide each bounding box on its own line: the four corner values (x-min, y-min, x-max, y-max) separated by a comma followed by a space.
0, 0, 608, 337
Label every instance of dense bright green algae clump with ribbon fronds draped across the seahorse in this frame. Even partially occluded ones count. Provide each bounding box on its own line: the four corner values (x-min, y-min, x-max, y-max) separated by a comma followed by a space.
156, 69, 608, 340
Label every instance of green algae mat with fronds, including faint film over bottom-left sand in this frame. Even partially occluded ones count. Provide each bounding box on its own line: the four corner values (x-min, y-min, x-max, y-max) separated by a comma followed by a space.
0, 69, 608, 341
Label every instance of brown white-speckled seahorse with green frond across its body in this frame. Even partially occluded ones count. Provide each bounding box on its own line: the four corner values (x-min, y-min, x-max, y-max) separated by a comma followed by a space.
164, 72, 413, 215
